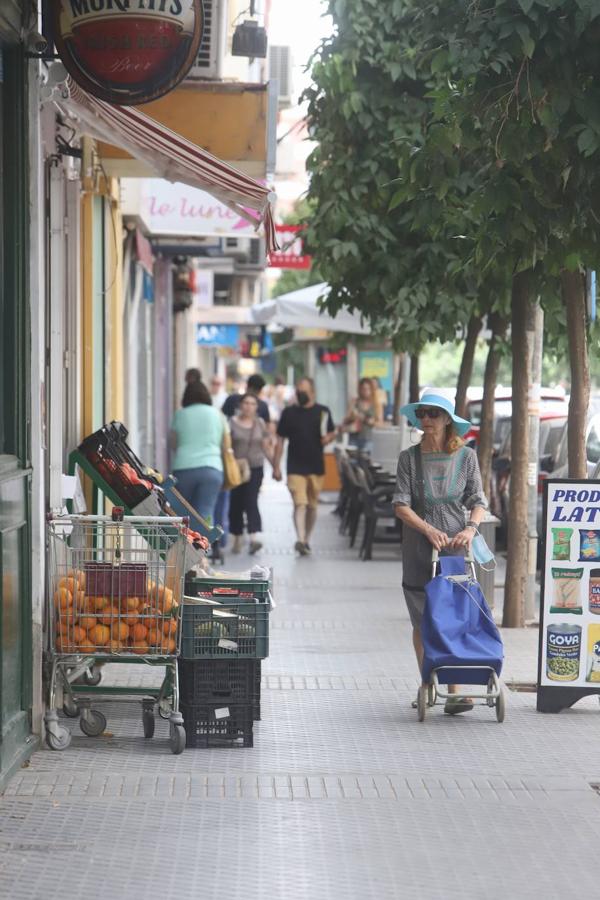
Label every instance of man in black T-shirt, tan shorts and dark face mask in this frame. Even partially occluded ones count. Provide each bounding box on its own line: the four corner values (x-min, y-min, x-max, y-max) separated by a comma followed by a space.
273, 378, 335, 556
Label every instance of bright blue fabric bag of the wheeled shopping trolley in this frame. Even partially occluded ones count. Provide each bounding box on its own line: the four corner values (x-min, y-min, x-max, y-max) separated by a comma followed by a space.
421, 556, 504, 684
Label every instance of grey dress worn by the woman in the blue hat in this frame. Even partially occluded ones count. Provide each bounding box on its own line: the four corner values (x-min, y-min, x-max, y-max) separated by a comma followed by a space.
392, 447, 488, 628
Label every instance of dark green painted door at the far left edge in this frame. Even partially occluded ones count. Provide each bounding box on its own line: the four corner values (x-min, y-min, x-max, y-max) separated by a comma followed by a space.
0, 48, 32, 785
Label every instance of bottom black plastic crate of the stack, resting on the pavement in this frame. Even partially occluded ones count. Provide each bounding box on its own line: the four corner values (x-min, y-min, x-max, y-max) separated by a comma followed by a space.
180, 702, 254, 748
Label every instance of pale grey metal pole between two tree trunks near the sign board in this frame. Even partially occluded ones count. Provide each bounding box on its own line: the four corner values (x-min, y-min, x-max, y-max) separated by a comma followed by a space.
525, 300, 544, 621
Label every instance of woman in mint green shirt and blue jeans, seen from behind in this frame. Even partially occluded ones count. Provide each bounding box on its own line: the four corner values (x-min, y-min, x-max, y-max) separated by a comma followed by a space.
171, 382, 228, 522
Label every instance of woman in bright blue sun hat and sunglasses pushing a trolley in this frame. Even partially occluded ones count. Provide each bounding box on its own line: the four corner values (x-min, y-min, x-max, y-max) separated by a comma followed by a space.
392, 390, 488, 715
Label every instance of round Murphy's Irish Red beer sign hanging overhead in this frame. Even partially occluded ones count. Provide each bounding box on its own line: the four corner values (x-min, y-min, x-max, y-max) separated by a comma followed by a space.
53, 0, 203, 105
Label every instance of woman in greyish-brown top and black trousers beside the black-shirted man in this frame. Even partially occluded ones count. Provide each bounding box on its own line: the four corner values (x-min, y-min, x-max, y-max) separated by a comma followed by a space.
229, 394, 273, 554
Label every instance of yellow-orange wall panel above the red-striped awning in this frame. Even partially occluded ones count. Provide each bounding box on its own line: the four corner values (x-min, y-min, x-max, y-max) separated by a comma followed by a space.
98, 82, 267, 172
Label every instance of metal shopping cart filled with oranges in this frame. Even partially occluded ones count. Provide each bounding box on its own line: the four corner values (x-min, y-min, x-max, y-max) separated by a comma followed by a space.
45, 509, 188, 753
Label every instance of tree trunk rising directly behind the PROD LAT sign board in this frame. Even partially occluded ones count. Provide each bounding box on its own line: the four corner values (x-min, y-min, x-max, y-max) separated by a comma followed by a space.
560, 270, 590, 478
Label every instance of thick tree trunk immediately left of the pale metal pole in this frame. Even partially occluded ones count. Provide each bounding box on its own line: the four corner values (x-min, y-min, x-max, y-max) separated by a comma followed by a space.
502, 270, 531, 628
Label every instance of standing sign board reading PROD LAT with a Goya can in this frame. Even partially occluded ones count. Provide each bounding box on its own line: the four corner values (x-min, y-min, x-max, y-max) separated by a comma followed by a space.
537, 478, 600, 712
